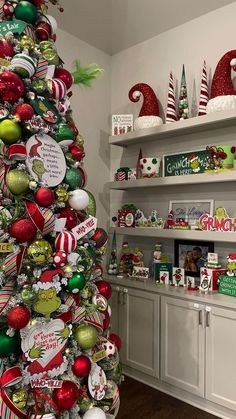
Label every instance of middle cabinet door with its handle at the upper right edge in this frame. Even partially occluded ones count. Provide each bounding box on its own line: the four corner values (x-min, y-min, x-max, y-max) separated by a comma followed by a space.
161, 297, 205, 396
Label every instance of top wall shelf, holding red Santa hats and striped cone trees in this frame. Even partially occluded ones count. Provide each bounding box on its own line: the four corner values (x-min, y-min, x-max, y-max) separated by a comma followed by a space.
109, 111, 236, 147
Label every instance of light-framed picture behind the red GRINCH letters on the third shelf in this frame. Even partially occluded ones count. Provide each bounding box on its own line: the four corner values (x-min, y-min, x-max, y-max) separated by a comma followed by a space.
169, 199, 214, 230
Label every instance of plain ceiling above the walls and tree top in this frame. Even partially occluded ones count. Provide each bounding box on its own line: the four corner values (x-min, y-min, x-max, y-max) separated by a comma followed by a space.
51, 0, 234, 55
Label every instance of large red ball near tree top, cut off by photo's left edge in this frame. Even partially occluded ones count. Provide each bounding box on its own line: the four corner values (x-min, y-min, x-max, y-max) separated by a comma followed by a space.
0, 71, 25, 103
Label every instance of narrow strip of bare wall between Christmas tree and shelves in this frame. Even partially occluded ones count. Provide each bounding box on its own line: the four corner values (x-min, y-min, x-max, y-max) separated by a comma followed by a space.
56, 30, 111, 231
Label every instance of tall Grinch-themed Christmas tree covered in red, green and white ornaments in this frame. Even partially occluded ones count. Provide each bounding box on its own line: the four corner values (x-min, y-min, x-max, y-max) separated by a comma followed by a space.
0, 0, 121, 419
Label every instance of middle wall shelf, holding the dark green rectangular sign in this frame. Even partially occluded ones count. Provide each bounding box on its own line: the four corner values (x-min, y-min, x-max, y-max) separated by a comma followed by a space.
109, 170, 236, 190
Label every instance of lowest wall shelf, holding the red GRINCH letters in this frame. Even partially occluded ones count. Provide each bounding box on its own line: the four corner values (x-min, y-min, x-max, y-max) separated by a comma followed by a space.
110, 227, 236, 245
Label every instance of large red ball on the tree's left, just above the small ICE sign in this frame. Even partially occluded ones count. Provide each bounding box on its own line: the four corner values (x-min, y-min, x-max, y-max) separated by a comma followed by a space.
10, 218, 37, 243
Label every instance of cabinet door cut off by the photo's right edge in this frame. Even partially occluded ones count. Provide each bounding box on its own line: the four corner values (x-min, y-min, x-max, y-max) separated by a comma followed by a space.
206, 307, 236, 410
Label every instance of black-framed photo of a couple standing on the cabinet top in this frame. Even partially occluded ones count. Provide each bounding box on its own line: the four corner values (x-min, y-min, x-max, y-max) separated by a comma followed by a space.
175, 240, 214, 277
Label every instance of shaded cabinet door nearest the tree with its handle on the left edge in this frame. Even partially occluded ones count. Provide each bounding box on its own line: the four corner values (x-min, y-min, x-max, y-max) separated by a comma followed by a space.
120, 288, 160, 378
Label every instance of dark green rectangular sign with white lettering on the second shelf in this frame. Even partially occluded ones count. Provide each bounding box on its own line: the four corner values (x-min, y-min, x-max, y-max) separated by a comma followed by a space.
163, 150, 210, 176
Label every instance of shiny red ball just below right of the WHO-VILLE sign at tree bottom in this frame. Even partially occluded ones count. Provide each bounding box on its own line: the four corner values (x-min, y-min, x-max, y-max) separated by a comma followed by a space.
53, 380, 79, 410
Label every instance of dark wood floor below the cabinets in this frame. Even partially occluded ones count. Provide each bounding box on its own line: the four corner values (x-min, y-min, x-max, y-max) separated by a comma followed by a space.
117, 377, 219, 419
